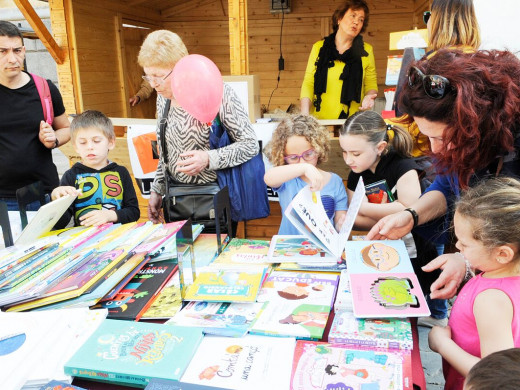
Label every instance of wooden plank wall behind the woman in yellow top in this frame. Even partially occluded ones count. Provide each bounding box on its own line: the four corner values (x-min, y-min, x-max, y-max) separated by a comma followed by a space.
163, 0, 418, 111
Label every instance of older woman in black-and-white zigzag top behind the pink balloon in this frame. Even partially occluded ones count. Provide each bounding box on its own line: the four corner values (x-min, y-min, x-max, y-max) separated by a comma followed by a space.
138, 30, 259, 223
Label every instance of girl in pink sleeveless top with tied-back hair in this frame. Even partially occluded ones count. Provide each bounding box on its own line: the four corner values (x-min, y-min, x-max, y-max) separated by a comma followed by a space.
428, 178, 520, 390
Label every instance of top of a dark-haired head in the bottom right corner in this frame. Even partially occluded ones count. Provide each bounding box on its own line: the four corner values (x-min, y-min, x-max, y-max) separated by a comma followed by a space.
464, 348, 520, 390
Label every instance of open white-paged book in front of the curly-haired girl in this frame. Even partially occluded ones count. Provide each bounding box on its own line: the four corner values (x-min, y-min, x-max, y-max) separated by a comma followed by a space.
268, 178, 365, 264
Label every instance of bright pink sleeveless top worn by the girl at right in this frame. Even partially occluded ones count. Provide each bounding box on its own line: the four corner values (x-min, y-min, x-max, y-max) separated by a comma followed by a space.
442, 274, 520, 390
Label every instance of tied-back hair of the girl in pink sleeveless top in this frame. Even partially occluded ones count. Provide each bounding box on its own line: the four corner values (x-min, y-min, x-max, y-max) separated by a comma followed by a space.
456, 177, 520, 248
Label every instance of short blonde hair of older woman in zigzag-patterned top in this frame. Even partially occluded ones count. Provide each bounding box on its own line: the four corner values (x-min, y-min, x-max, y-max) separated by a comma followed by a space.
137, 30, 188, 68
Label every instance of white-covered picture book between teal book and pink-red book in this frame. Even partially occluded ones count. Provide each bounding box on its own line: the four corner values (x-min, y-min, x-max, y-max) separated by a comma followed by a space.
181, 335, 295, 390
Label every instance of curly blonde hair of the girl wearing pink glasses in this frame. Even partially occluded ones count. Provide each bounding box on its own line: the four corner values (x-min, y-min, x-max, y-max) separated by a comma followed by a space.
264, 114, 330, 166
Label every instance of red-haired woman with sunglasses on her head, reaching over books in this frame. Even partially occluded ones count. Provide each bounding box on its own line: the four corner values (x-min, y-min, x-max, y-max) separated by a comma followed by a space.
367, 49, 520, 298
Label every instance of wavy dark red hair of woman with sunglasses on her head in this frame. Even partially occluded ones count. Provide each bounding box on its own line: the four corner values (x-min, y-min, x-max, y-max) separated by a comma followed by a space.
399, 49, 520, 188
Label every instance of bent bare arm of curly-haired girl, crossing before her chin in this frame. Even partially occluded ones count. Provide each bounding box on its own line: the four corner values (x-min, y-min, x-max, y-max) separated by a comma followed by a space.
264, 163, 326, 191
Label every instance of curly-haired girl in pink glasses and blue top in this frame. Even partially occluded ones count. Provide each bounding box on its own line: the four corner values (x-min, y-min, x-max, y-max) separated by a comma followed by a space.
264, 115, 347, 235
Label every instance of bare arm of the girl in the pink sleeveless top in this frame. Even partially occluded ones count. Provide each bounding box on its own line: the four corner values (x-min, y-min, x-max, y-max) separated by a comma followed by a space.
428, 289, 514, 376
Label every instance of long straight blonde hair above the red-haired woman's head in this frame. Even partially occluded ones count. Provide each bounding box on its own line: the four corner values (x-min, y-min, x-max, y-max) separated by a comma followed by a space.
430, 0, 480, 51
